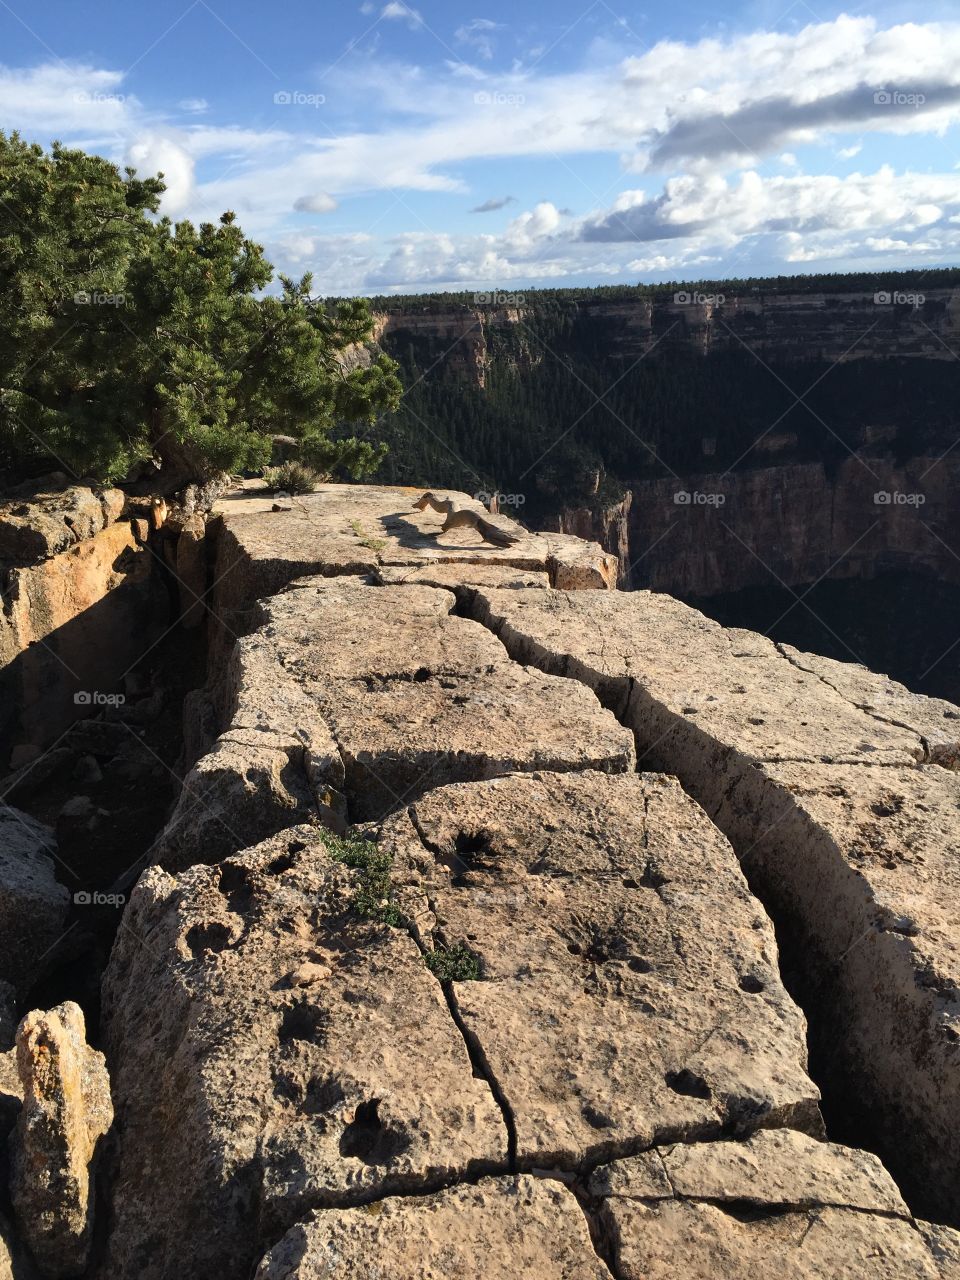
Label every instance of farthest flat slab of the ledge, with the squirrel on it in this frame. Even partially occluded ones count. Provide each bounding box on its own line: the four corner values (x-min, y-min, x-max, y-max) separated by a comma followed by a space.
209, 484, 617, 616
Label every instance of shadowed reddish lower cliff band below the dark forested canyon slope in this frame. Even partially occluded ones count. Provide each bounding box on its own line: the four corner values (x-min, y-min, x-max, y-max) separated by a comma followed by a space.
557, 454, 960, 596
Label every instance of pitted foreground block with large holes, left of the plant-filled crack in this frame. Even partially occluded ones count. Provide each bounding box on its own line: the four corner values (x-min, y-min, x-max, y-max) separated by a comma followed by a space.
104, 828, 507, 1280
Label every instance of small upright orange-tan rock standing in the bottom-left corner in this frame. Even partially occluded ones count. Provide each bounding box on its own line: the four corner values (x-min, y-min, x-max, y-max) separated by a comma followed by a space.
10, 1001, 113, 1277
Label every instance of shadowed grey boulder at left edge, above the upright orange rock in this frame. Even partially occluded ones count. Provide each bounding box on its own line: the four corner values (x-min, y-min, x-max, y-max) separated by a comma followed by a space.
0, 804, 69, 987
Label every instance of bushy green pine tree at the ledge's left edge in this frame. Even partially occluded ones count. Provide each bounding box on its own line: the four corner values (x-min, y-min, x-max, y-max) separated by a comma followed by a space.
0, 132, 402, 486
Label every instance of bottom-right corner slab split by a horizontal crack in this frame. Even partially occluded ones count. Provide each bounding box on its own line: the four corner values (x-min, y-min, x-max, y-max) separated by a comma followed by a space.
590, 1130, 960, 1280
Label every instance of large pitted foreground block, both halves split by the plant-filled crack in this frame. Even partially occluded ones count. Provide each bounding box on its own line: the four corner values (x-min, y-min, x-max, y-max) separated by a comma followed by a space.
97, 771, 819, 1280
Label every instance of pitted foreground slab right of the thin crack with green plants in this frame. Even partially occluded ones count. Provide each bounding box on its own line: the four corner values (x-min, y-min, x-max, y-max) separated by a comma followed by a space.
381, 772, 820, 1169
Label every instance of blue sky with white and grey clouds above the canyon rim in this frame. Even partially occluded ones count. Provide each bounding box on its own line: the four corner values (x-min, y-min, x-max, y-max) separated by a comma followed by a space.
0, 0, 960, 294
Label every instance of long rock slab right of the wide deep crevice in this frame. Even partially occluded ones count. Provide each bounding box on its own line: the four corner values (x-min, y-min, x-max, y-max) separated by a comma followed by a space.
474, 590, 960, 1220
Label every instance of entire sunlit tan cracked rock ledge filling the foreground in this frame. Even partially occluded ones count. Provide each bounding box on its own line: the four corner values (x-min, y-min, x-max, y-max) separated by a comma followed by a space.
0, 486, 960, 1280
